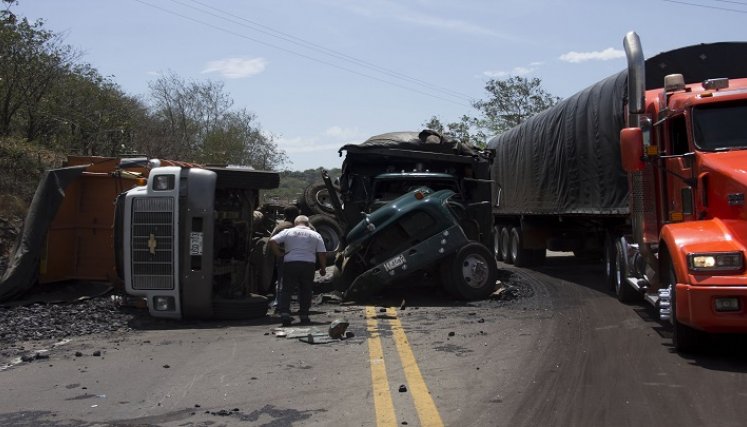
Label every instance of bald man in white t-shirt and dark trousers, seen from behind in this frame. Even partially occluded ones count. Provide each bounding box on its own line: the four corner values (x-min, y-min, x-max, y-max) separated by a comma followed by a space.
269, 215, 327, 326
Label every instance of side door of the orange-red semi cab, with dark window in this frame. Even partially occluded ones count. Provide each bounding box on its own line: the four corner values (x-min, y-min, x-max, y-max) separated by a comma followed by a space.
662, 115, 695, 222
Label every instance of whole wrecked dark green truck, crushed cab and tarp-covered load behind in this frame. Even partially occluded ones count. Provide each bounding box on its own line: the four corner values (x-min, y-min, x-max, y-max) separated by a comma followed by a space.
323, 130, 496, 299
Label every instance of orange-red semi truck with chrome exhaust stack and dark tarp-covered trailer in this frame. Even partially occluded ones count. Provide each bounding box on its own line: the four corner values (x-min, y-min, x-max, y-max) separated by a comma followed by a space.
489, 32, 747, 352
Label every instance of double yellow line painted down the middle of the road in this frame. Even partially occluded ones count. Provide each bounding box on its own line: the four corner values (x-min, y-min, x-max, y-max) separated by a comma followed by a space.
366, 307, 444, 427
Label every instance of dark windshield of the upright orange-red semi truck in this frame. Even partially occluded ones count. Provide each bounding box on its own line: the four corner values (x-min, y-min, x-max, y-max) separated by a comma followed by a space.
693, 101, 747, 151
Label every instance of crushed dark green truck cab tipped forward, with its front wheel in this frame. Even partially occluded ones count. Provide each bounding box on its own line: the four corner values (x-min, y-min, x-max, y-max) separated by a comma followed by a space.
338, 187, 497, 300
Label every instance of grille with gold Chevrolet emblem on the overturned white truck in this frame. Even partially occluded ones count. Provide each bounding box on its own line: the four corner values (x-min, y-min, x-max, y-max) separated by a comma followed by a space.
130, 197, 174, 290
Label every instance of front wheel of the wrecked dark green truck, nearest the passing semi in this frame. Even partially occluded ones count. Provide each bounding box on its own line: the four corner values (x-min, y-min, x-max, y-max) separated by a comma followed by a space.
444, 242, 498, 301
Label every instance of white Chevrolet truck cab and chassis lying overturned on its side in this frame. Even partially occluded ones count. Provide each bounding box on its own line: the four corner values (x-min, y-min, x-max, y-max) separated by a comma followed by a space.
117, 167, 280, 319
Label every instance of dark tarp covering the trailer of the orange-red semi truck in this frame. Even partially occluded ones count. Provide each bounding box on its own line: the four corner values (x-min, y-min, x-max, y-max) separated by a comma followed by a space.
488, 42, 747, 215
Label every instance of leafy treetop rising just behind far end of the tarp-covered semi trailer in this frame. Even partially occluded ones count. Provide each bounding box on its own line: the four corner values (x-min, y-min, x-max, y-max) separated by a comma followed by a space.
472, 76, 560, 135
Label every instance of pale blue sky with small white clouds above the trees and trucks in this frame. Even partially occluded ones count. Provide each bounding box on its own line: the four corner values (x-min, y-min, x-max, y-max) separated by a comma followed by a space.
11, 0, 747, 170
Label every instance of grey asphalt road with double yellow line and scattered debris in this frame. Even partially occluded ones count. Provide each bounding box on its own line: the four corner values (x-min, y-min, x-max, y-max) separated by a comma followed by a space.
0, 252, 747, 427
